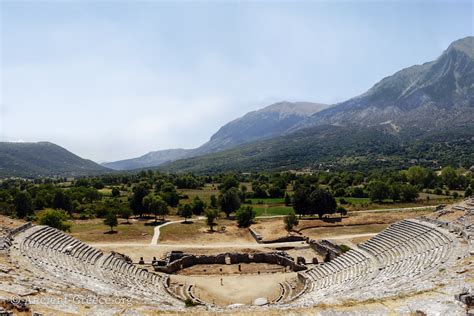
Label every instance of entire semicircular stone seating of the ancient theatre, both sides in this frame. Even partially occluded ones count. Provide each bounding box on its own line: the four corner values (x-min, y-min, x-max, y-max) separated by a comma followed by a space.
2, 201, 474, 314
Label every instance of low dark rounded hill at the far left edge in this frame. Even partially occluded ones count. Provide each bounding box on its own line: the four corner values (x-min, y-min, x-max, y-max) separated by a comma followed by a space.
0, 142, 111, 178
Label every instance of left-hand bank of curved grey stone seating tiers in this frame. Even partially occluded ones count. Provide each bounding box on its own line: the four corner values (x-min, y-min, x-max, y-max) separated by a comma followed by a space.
12, 226, 181, 305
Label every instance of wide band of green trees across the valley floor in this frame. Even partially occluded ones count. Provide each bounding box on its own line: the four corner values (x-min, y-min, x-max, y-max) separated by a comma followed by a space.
0, 166, 474, 225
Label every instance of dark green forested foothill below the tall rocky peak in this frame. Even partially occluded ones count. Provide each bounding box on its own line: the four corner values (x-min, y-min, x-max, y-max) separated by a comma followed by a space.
160, 124, 474, 174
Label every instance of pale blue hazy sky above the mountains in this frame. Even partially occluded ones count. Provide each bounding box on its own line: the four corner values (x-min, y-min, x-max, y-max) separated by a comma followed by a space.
0, 0, 473, 161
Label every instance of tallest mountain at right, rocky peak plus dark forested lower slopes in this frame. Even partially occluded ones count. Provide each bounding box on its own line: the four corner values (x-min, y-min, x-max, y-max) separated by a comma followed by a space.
160, 37, 474, 173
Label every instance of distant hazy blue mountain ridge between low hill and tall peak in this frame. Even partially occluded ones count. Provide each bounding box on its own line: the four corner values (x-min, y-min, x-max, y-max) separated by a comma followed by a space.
102, 101, 327, 170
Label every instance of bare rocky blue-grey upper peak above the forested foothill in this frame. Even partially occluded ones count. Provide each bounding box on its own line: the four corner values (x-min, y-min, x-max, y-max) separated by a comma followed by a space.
297, 36, 474, 130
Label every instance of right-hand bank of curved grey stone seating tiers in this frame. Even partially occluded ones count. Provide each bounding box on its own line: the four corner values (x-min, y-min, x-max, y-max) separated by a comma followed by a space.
302, 220, 454, 297
